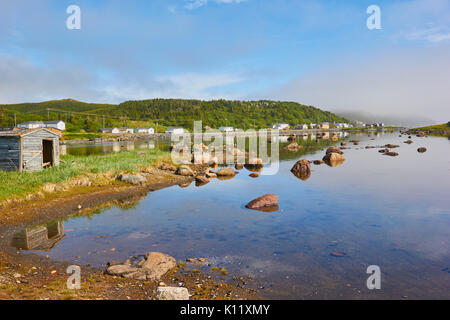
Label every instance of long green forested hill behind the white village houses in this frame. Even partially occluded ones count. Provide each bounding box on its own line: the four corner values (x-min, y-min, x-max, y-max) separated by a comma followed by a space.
0, 99, 347, 131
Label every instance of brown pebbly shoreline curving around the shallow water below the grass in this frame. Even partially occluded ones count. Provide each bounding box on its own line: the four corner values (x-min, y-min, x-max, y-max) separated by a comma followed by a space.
0, 168, 258, 300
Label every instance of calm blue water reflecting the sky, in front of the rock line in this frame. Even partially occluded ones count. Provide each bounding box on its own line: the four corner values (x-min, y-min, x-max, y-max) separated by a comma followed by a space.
14, 133, 450, 299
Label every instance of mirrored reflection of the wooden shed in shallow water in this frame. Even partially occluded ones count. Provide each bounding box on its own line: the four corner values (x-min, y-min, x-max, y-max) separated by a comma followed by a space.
11, 221, 65, 251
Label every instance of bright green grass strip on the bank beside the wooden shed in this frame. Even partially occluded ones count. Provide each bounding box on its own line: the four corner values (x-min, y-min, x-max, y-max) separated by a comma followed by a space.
0, 149, 169, 201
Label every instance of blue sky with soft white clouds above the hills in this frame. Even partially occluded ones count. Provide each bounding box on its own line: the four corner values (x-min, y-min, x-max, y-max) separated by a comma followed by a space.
0, 0, 450, 123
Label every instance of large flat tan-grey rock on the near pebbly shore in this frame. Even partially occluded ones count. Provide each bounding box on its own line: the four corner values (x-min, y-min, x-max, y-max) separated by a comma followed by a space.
105, 252, 176, 280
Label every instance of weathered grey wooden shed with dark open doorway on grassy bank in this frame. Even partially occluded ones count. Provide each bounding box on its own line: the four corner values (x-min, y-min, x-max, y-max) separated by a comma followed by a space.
0, 128, 59, 171
